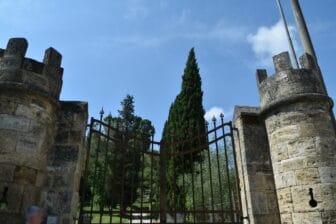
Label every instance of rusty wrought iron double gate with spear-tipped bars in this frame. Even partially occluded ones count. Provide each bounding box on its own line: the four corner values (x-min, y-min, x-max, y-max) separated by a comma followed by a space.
78, 114, 242, 224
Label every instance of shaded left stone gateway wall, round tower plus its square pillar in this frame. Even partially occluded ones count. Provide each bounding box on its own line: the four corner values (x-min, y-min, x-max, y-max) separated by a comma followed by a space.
0, 38, 87, 224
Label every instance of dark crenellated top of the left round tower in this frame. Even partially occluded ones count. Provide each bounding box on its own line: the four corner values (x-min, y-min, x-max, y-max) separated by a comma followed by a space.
0, 38, 63, 99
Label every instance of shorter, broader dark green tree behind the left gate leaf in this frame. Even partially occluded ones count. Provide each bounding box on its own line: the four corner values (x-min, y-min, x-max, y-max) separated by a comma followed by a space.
89, 95, 154, 214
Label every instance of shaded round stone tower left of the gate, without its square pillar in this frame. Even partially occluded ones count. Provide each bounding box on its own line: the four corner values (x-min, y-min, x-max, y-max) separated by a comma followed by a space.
0, 38, 63, 223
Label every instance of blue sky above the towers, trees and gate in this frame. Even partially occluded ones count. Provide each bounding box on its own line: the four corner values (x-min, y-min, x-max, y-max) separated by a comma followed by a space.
0, 0, 336, 138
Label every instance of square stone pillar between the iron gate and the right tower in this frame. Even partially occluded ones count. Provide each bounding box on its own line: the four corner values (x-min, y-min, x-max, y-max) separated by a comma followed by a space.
234, 106, 280, 224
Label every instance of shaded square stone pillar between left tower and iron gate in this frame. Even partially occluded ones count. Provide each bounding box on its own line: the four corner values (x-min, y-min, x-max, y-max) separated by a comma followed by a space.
41, 101, 88, 224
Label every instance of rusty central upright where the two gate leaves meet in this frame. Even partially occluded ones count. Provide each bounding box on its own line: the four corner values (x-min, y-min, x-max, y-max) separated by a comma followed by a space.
160, 142, 167, 223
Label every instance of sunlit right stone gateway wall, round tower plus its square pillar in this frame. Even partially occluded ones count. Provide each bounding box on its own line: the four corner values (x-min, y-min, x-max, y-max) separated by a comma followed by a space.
234, 52, 336, 224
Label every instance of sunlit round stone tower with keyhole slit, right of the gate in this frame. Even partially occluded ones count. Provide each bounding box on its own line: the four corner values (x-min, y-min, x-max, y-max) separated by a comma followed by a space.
257, 52, 336, 224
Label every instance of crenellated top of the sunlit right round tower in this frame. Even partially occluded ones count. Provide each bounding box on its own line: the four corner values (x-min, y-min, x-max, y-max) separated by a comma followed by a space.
256, 52, 327, 108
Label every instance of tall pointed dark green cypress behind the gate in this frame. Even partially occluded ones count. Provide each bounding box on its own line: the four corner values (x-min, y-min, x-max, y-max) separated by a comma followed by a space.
162, 48, 206, 212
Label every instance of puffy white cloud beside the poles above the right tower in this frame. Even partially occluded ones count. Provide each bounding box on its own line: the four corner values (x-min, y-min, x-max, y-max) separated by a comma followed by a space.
247, 20, 299, 66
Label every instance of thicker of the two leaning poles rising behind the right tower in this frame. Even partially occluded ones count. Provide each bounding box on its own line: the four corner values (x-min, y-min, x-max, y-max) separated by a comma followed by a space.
291, 0, 317, 62
